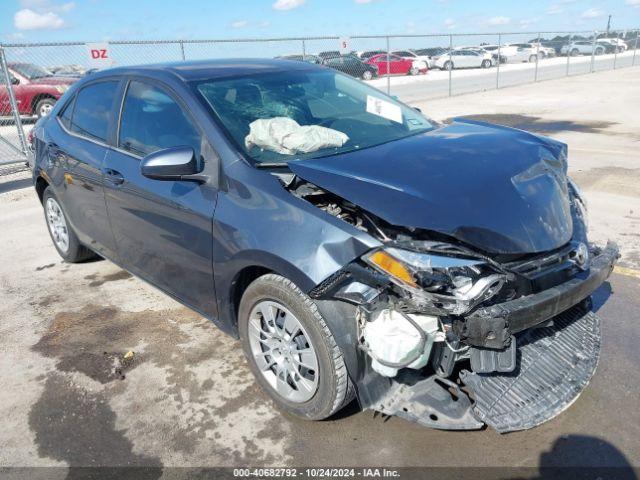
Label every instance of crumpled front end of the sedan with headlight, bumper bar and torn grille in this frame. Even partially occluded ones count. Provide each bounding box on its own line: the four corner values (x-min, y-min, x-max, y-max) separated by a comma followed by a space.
289, 171, 619, 432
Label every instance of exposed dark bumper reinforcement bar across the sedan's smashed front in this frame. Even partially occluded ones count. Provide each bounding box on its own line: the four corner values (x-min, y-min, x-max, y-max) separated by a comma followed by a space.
456, 242, 620, 349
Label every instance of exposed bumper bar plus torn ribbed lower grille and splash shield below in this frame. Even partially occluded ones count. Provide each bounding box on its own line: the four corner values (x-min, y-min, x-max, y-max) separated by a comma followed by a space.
359, 243, 619, 433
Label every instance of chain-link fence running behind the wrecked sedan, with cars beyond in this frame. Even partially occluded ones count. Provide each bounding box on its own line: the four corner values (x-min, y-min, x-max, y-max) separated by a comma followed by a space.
0, 29, 640, 165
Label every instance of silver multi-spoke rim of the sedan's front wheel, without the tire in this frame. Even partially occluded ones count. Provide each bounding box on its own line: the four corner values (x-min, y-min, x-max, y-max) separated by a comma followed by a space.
248, 300, 319, 403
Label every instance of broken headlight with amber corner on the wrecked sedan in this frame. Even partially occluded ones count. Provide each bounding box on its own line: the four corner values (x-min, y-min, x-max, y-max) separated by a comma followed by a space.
363, 248, 506, 315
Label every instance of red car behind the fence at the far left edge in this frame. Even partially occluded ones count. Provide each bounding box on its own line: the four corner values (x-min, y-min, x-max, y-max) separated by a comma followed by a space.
0, 63, 78, 118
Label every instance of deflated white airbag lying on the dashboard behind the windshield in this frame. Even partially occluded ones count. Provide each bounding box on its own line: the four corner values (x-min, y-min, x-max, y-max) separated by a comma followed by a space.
244, 117, 349, 155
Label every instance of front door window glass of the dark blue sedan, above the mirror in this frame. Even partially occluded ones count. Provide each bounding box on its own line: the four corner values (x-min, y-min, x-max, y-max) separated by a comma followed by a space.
118, 81, 201, 156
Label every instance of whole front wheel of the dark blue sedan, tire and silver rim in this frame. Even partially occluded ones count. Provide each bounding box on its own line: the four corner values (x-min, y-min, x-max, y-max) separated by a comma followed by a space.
238, 274, 356, 420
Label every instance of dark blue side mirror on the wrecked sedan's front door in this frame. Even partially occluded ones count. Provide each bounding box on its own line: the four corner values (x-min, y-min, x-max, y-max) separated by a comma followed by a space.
140, 147, 209, 183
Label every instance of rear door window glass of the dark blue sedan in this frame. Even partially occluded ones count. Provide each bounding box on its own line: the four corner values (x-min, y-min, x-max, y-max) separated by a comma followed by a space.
65, 81, 119, 142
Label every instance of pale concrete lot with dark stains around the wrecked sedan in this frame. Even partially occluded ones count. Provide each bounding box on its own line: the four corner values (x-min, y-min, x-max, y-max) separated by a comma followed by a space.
0, 68, 640, 478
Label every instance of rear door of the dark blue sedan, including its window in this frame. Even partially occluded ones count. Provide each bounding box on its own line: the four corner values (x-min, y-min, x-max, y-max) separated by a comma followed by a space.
47, 79, 120, 257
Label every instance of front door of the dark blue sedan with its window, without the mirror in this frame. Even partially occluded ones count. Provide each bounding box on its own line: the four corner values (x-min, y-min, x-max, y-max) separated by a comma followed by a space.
104, 78, 217, 317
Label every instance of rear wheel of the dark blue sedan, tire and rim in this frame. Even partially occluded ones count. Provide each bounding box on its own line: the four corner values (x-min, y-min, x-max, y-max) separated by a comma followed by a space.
42, 187, 96, 263
